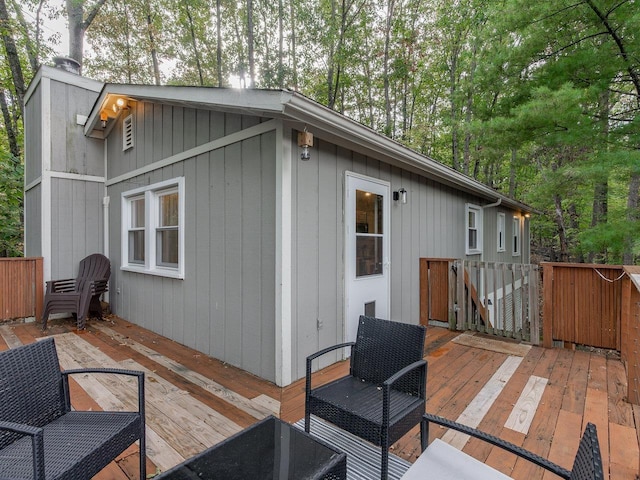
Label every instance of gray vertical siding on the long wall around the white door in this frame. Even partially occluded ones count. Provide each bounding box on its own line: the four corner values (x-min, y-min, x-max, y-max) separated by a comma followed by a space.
291, 131, 525, 380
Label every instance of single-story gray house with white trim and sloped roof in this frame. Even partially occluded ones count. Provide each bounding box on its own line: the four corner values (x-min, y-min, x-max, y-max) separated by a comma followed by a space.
25, 66, 530, 386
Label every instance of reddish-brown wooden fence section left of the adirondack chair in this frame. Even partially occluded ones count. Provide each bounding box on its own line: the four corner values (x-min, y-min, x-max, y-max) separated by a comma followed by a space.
0, 257, 44, 320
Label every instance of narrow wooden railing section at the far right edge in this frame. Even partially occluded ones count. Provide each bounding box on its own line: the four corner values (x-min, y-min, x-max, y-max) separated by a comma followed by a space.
620, 267, 640, 405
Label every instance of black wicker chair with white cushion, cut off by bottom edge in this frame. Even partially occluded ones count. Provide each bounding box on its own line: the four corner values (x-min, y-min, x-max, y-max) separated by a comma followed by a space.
403, 413, 604, 480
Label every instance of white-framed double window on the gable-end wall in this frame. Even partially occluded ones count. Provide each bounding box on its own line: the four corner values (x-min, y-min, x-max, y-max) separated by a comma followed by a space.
121, 177, 184, 278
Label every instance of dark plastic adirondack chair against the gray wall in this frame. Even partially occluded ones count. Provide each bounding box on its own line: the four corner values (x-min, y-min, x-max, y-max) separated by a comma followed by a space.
42, 253, 111, 330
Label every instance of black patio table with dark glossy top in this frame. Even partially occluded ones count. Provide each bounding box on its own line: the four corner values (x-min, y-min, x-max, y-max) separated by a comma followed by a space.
155, 416, 347, 480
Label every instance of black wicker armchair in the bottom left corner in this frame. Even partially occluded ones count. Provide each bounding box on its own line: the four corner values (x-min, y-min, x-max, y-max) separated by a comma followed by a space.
0, 338, 146, 480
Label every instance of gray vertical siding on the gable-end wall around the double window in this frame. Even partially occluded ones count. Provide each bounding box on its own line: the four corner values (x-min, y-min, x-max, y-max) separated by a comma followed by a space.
108, 102, 276, 381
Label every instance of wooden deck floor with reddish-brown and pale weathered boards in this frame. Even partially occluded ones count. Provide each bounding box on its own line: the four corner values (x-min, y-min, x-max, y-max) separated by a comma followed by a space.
0, 317, 640, 480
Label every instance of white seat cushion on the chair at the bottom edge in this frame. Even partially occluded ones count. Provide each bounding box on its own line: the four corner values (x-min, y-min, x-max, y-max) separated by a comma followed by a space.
402, 439, 511, 480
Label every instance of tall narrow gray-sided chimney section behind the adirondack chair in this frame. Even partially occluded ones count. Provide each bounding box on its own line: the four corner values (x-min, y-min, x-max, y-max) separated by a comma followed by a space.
25, 71, 104, 280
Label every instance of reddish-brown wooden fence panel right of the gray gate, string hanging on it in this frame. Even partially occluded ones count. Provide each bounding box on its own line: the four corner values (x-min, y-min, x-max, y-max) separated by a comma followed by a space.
542, 263, 624, 351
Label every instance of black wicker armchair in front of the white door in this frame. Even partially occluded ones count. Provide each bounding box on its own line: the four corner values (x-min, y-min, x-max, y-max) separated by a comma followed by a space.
305, 316, 427, 479
